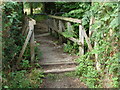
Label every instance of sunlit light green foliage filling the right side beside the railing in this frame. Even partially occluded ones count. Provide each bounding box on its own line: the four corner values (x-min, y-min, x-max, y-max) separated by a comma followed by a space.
77, 3, 120, 88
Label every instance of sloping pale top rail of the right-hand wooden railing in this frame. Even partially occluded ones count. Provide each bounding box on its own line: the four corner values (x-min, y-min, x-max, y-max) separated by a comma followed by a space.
48, 15, 81, 23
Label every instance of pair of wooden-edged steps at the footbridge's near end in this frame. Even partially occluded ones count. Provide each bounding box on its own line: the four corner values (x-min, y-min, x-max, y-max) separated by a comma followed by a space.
40, 62, 77, 74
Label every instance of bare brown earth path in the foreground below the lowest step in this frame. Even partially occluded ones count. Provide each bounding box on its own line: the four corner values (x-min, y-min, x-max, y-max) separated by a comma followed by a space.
41, 73, 87, 88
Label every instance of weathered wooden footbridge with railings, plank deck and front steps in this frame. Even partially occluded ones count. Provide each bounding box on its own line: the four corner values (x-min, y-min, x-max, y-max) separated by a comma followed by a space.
17, 15, 97, 73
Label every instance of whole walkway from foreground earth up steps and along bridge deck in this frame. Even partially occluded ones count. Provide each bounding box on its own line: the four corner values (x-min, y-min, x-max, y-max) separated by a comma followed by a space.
35, 20, 86, 88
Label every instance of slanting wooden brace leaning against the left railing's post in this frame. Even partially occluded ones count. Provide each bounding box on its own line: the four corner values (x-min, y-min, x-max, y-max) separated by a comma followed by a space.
17, 21, 34, 64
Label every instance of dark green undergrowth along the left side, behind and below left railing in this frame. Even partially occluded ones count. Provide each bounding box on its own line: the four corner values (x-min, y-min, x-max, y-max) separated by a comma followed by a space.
2, 1, 44, 88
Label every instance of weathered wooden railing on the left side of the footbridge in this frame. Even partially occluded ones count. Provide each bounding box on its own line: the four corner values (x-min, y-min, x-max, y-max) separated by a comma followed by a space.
17, 16, 36, 64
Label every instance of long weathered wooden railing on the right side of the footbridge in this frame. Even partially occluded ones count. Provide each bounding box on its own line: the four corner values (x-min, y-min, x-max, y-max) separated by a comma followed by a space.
48, 15, 92, 55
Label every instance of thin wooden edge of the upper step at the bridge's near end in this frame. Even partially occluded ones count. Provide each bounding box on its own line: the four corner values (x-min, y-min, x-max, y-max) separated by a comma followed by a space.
39, 62, 78, 66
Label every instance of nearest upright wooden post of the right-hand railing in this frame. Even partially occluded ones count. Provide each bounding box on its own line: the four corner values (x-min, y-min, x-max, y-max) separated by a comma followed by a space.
79, 25, 84, 56
